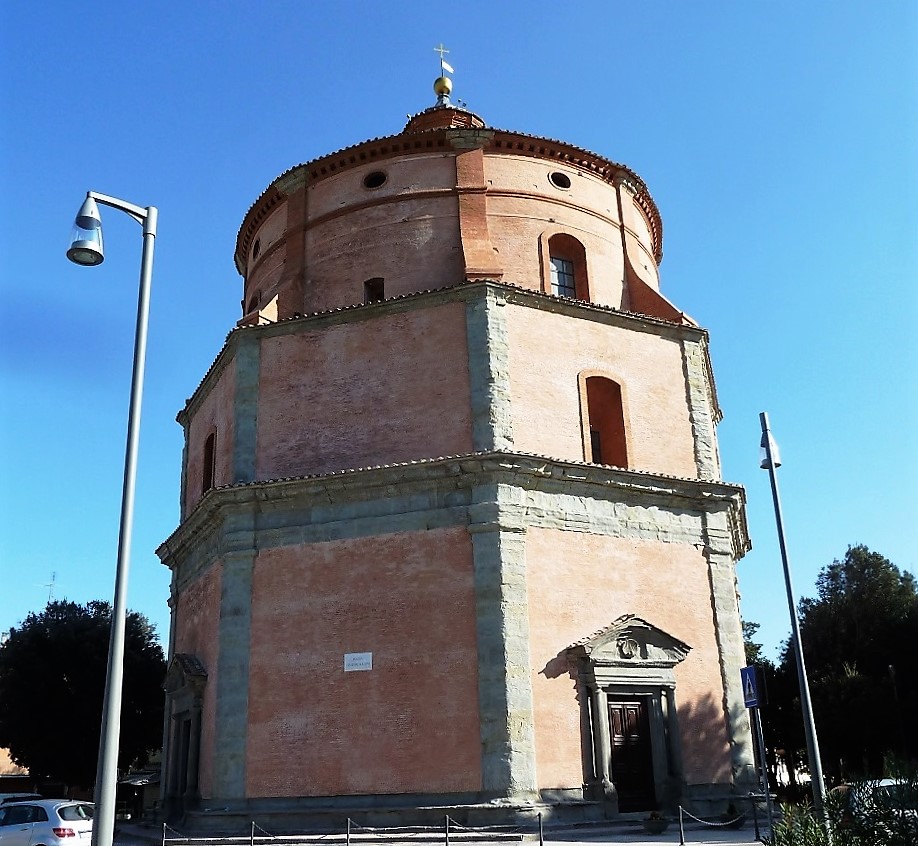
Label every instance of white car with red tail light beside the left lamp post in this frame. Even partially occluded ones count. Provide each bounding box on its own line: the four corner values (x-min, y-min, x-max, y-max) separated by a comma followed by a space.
0, 799, 93, 846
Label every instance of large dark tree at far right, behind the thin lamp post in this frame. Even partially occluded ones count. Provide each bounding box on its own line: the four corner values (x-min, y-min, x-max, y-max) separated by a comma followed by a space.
796, 546, 918, 779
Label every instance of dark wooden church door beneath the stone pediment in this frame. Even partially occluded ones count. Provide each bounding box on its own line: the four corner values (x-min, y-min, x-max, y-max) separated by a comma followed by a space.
609, 694, 656, 813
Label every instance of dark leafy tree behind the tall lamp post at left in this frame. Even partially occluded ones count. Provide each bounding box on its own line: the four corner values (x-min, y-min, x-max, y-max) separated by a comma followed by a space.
0, 602, 166, 788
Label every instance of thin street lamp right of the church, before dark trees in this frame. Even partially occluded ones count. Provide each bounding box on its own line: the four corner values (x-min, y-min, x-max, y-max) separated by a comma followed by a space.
759, 411, 826, 821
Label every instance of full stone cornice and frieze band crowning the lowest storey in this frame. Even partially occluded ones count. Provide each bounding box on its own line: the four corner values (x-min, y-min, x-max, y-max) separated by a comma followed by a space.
157, 450, 749, 584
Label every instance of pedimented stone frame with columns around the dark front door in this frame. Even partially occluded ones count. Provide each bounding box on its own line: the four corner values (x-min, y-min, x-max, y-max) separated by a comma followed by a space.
566, 614, 691, 813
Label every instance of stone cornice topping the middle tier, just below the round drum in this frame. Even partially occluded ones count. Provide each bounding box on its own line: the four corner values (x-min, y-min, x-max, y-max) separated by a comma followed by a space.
176, 279, 708, 426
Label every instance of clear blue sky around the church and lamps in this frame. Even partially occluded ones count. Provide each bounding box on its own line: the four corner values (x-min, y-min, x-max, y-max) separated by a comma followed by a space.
0, 0, 918, 654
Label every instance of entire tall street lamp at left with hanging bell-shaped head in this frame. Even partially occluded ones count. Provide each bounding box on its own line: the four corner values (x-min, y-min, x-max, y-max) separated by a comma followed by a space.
67, 191, 157, 846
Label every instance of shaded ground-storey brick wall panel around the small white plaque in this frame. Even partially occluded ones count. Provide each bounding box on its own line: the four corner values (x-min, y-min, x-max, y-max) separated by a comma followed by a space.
246, 527, 481, 796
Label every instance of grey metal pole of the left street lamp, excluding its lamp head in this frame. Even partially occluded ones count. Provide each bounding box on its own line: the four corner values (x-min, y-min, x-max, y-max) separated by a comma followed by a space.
92, 203, 157, 846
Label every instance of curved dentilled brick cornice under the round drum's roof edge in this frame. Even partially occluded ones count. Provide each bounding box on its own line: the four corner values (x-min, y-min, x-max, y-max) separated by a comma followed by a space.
234, 127, 663, 275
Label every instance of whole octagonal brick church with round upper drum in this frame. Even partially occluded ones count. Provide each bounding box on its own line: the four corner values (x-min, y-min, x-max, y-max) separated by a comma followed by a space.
158, 77, 753, 830
